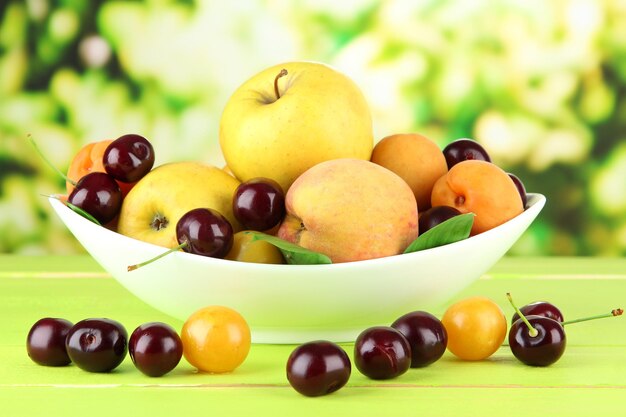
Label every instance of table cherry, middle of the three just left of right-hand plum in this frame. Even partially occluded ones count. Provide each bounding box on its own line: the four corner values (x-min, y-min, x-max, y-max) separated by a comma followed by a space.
354, 326, 411, 379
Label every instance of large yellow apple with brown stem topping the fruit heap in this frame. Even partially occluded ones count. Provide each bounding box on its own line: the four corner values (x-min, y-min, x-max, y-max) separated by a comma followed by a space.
219, 62, 374, 190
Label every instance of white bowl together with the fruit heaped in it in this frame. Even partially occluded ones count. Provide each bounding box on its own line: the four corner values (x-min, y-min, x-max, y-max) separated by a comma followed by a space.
41, 63, 545, 343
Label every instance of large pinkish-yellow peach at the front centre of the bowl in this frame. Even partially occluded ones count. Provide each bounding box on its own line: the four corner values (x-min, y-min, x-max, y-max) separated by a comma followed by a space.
278, 158, 418, 263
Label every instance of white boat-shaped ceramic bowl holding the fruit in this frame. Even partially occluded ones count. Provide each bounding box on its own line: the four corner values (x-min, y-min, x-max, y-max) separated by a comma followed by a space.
50, 194, 546, 343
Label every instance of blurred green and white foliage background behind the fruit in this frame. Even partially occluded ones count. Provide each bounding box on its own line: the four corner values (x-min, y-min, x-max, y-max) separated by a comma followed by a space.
0, 0, 626, 256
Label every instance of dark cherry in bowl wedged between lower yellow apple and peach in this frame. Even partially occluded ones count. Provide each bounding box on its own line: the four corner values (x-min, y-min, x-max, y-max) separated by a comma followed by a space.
233, 178, 286, 231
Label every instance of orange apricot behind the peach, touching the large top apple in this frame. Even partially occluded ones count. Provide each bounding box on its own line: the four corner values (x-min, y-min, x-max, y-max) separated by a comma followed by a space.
371, 133, 448, 212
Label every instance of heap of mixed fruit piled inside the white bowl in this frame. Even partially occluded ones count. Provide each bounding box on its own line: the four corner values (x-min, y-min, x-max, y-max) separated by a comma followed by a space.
30, 62, 526, 269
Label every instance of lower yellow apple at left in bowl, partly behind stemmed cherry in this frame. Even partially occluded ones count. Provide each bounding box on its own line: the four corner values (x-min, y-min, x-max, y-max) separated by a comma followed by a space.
117, 162, 241, 248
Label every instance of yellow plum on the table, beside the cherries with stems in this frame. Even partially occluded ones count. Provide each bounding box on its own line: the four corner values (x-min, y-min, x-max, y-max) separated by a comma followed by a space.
441, 297, 507, 361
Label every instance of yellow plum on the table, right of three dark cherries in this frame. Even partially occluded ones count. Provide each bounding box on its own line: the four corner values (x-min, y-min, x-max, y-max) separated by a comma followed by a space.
180, 306, 251, 373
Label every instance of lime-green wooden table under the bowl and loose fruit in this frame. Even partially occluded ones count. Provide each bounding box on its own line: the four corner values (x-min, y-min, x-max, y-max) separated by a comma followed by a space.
0, 255, 626, 417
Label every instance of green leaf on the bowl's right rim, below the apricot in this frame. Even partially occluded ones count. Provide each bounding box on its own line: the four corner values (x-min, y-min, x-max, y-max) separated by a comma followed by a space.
404, 213, 474, 253
